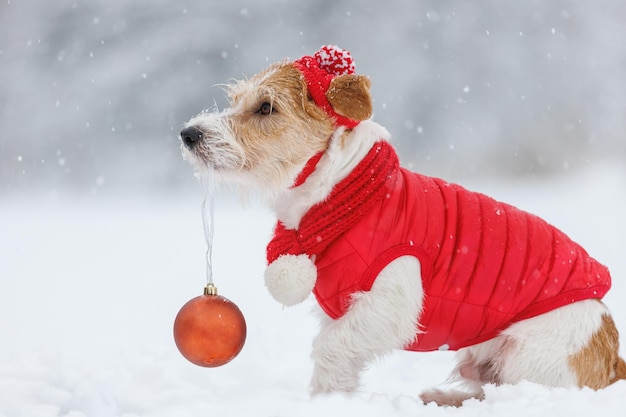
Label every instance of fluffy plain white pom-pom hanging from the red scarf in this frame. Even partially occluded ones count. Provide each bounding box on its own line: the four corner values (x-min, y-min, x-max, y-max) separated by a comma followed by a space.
265, 255, 317, 307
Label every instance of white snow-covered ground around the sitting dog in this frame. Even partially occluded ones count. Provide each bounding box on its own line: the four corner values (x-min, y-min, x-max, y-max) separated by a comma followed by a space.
0, 163, 626, 417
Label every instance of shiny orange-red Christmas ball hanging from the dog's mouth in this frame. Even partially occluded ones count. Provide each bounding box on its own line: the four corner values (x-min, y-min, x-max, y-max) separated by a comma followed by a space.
174, 284, 246, 368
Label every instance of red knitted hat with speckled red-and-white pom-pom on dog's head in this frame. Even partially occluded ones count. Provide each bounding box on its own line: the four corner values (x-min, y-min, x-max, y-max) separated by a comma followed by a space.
294, 45, 359, 129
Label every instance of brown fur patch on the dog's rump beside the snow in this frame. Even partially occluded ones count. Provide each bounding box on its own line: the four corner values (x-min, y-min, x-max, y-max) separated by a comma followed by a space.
569, 315, 626, 389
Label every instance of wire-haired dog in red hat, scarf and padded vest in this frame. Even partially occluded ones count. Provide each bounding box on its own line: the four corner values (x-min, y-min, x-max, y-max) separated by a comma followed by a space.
180, 45, 626, 406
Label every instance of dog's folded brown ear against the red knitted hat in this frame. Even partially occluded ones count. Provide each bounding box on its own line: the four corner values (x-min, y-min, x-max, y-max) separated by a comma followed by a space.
326, 74, 372, 120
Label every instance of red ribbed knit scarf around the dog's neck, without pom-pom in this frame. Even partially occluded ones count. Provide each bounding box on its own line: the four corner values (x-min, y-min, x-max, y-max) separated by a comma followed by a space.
267, 141, 399, 263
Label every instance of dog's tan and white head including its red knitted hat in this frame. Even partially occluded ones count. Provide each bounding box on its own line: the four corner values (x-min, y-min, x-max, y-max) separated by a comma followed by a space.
180, 46, 372, 190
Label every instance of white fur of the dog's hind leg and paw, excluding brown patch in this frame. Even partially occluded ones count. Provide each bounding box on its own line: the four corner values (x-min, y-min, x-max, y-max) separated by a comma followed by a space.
421, 300, 609, 405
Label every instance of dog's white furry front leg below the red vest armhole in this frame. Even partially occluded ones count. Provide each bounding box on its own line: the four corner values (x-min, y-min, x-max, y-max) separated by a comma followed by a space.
311, 256, 423, 394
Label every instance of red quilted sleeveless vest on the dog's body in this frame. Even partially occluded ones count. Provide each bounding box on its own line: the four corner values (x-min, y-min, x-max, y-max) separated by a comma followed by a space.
313, 155, 611, 351
